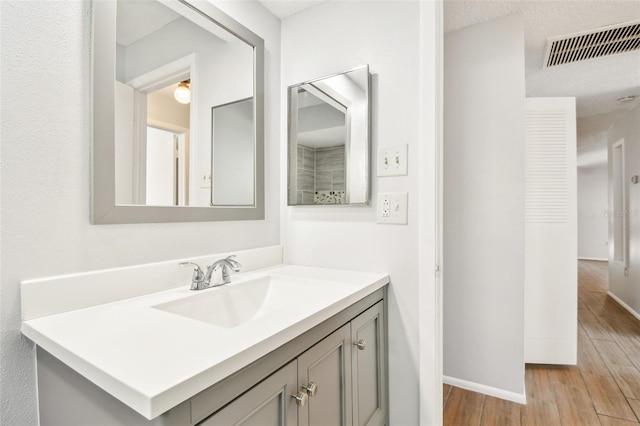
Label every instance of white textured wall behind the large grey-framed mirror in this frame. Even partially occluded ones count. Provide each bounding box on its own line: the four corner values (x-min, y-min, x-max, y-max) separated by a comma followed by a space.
0, 1, 281, 426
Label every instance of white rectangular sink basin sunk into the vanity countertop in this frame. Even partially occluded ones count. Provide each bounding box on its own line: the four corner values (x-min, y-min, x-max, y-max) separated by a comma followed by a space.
153, 275, 325, 328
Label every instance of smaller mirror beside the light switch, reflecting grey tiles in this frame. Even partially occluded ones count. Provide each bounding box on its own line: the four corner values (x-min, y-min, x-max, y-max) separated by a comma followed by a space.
287, 65, 371, 206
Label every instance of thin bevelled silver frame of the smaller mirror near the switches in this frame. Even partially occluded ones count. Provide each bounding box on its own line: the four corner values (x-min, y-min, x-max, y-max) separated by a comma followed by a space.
286, 64, 372, 207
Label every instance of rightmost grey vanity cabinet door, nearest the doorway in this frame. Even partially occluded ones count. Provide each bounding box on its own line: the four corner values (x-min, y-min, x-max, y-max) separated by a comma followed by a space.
351, 303, 387, 426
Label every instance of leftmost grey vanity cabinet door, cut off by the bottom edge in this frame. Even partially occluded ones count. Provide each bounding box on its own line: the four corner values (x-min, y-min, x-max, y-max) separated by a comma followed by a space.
198, 360, 298, 426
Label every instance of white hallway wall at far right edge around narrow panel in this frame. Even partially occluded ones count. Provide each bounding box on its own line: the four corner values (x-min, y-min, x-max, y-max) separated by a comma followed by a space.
609, 106, 640, 318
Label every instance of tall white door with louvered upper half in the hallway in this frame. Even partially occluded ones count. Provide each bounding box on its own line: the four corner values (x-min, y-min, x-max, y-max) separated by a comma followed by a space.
525, 98, 578, 365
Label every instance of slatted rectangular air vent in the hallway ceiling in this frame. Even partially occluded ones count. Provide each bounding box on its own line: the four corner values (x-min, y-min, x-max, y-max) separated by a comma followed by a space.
544, 20, 640, 67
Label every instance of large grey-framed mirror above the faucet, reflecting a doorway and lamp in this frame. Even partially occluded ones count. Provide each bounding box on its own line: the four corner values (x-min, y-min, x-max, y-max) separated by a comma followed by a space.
91, 0, 264, 224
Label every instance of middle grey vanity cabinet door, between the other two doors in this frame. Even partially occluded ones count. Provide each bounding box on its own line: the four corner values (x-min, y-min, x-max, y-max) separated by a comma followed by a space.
298, 324, 352, 426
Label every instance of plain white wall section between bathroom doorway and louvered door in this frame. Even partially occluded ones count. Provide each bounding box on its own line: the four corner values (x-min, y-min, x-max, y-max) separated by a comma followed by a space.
443, 15, 525, 400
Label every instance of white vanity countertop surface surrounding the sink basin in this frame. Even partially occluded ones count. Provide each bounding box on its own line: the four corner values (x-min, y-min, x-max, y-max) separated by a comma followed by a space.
22, 265, 389, 419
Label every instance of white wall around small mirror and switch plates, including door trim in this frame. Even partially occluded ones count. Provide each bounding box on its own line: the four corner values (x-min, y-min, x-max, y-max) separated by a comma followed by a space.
281, 1, 442, 425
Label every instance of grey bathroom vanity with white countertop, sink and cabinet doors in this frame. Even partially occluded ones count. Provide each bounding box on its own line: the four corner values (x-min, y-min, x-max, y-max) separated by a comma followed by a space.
22, 248, 389, 426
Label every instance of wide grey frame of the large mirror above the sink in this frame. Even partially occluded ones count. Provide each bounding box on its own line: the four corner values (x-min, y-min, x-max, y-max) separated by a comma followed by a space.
91, 0, 264, 224
